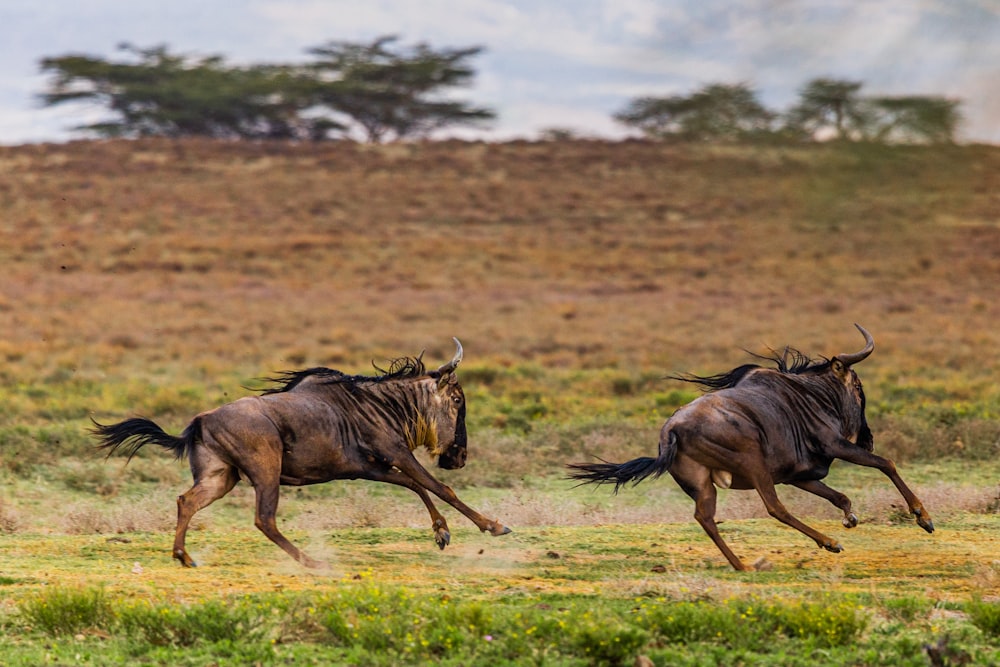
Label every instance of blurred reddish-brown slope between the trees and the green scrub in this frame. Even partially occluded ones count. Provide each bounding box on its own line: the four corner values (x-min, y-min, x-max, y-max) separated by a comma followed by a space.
0, 140, 1000, 383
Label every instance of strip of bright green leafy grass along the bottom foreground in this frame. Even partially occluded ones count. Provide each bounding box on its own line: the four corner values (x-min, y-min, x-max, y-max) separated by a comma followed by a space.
0, 576, 1000, 665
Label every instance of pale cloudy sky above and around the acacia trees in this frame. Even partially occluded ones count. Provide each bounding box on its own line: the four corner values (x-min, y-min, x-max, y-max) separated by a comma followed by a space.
0, 0, 1000, 145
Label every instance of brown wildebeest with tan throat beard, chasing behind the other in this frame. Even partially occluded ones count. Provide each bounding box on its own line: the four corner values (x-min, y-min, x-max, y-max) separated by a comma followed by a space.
93, 338, 510, 567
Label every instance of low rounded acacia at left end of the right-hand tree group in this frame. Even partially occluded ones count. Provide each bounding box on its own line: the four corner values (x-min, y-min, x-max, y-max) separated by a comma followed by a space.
614, 83, 775, 141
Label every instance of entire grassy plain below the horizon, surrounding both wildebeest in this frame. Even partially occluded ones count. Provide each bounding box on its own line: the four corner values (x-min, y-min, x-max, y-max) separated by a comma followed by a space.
0, 141, 1000, 665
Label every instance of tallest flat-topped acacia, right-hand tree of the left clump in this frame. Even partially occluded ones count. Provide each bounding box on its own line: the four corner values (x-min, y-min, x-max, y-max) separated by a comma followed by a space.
307, 36, 495, 143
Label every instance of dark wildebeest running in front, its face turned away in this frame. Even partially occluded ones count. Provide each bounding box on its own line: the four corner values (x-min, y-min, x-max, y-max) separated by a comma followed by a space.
569, 324, 934, 570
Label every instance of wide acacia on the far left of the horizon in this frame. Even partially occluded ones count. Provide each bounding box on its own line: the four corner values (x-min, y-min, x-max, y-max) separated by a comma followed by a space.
41, 44, 308, 138
